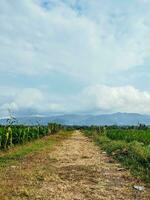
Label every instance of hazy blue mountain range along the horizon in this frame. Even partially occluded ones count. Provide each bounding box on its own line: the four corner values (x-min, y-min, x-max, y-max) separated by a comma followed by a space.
0, 113, 150, 125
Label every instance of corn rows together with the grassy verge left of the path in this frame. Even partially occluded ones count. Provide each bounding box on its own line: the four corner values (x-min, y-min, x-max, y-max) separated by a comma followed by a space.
0, 123, 72, 169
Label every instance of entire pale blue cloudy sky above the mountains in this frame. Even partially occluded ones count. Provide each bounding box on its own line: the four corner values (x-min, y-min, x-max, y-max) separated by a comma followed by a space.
0, 0, 150, 117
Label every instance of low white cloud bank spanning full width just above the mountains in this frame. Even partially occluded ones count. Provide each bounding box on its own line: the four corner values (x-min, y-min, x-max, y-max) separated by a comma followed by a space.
0, 85, 150, 117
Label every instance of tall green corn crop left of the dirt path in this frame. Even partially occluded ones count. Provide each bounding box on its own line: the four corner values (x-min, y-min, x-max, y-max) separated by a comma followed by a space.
0, 123, 62, 150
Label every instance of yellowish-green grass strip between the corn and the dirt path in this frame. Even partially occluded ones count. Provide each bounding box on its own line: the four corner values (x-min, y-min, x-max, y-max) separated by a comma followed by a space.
0, 131, 71, 168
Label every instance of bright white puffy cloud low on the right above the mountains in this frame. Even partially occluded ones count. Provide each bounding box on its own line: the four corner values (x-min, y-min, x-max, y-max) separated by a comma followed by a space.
79, 85, 150, 113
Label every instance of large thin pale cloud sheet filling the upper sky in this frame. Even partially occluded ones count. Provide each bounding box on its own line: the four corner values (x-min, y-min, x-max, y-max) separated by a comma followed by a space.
0, 0, 150, 82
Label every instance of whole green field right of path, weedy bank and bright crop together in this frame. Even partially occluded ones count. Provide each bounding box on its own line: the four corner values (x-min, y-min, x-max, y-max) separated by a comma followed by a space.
84, 127, 150, 184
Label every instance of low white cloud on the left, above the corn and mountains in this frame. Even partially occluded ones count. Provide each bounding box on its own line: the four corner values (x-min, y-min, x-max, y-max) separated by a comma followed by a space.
0, 88, 64, 117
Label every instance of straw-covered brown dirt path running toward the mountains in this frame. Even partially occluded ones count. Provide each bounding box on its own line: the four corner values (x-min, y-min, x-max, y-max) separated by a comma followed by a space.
0, 131, 150, 200
